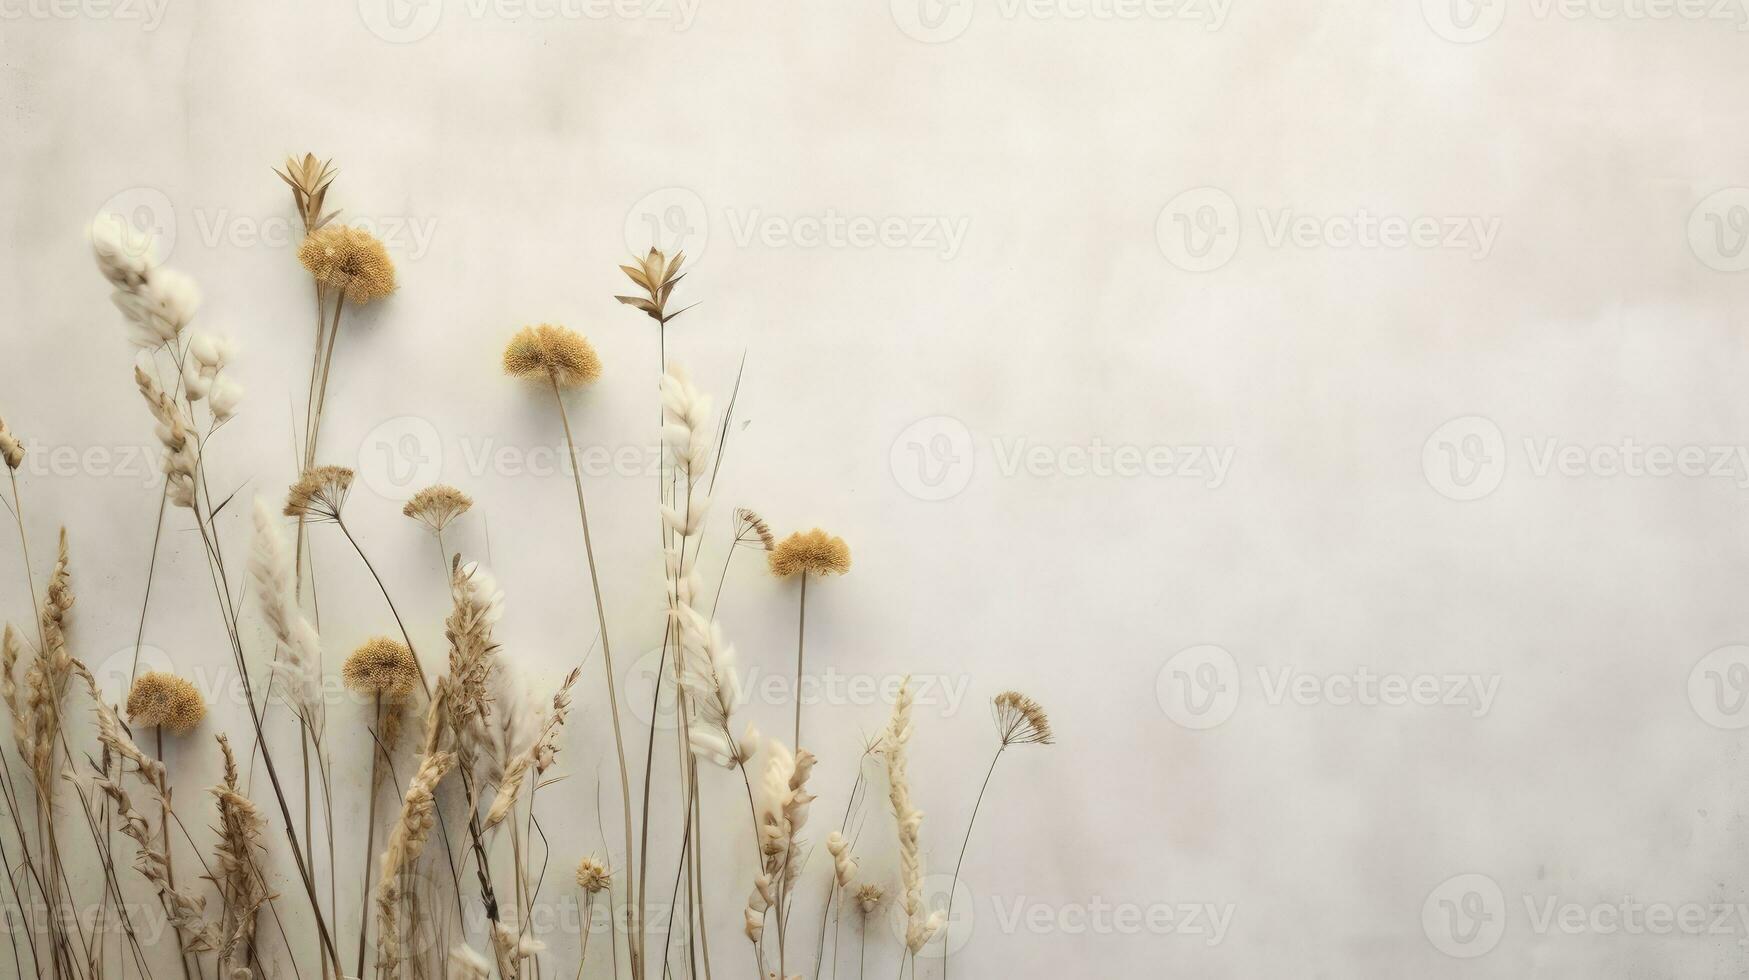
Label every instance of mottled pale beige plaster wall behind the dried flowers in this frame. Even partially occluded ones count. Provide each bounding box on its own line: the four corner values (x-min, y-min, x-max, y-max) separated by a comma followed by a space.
0, 0, 1749, 978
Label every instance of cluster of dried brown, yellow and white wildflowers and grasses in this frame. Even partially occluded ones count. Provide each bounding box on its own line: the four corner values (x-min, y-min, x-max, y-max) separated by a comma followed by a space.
0, 156, 1053, 980
